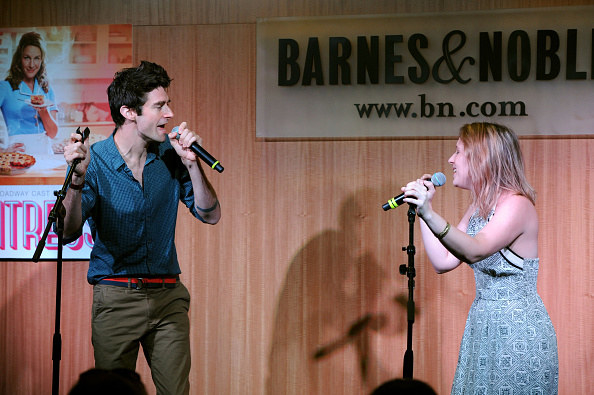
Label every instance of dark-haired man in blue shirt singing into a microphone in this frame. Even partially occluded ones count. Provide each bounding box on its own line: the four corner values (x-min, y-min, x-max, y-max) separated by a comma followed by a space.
64, 61, 221, 394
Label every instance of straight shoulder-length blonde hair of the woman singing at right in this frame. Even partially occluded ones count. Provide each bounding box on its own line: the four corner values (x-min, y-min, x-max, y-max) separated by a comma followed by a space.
460, 122, 536, 218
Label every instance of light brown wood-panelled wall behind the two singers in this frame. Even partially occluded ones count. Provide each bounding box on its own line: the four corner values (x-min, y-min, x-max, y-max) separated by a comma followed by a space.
0, 0, 594, 394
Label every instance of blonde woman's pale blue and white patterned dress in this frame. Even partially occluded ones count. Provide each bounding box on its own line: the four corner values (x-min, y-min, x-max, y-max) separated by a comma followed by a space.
452, 213, 559, 395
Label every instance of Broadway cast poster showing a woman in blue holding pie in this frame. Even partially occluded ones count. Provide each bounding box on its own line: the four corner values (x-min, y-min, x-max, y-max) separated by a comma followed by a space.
0, 25, 132, 260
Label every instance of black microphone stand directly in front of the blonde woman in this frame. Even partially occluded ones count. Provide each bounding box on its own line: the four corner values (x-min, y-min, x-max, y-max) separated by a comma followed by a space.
399, 203, 417, 379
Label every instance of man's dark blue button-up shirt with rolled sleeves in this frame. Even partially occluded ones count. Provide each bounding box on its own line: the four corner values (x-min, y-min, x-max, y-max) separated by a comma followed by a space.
69, 134, 202, 284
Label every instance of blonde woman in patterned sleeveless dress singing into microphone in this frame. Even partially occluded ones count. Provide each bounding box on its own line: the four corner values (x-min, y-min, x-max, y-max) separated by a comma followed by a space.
402, 123, 559, 394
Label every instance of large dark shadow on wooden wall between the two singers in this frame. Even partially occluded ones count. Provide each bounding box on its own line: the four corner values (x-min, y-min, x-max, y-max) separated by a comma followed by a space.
266, 189, 414, 395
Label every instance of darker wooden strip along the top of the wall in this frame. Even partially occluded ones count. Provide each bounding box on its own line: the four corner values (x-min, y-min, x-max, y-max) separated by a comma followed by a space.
0, 0, 592, 26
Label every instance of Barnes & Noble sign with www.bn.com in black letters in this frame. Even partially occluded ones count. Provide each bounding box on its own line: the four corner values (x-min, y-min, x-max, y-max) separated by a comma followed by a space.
256, 7, 594, 138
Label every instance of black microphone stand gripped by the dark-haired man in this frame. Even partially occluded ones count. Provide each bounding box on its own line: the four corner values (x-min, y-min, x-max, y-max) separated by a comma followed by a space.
32, 127, 90, 395
